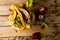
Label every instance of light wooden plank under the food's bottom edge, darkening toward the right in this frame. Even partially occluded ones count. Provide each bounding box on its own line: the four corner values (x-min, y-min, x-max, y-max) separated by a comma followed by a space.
0, 26, 56, 37
